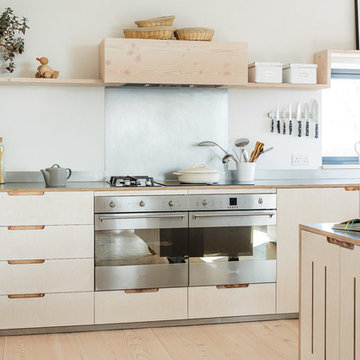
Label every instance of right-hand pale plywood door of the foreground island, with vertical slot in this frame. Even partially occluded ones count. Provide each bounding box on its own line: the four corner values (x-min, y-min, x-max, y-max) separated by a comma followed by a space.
340, 246, 360, 360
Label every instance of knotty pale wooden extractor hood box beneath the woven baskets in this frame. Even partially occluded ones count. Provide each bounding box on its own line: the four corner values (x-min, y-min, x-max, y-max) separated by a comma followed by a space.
100, 38, 248, 87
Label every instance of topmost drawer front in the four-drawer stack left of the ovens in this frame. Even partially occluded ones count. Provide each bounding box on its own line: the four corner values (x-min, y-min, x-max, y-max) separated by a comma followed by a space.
0, 191, 93, 226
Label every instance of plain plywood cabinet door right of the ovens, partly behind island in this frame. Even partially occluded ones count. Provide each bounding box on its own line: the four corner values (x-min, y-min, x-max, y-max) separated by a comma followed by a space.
276, 188, 360, 313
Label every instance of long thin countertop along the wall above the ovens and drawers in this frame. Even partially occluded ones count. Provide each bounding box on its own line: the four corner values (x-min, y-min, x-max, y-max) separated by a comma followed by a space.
0, 179, 360, 192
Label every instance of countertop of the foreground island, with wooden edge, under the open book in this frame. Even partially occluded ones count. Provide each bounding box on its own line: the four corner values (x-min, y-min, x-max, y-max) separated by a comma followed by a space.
299, 223, 360, 246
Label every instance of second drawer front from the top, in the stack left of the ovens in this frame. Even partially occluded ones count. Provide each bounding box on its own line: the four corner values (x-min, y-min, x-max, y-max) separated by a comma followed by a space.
0, 225, 94, 260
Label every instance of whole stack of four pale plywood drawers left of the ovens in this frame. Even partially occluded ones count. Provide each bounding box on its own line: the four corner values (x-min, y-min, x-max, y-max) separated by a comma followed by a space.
0, 191, 94, 329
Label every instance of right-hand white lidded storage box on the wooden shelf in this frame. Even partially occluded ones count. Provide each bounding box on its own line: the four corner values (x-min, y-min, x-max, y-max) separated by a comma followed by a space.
283, 64, 317, 84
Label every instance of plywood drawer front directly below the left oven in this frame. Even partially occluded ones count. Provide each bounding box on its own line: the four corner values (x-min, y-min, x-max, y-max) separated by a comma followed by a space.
95, 288, 187, 324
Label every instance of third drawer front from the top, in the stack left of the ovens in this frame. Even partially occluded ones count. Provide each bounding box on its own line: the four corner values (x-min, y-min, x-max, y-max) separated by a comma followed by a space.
0, 259, 94, 295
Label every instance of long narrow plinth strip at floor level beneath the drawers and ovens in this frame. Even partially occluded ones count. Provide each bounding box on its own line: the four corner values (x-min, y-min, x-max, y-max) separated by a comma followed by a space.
0, 313, 299, 336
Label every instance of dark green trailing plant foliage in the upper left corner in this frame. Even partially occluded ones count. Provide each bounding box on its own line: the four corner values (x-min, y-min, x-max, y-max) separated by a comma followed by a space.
0, 8, 29, 72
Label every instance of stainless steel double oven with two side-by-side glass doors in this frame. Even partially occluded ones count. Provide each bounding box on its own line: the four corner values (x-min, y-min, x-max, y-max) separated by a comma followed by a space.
95, 194, 276, 291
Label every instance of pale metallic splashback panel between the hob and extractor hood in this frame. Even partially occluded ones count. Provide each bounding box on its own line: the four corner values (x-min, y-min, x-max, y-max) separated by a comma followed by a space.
105, 88, 228, 179
